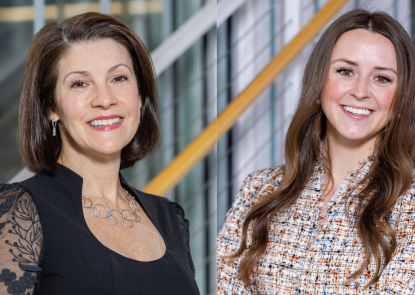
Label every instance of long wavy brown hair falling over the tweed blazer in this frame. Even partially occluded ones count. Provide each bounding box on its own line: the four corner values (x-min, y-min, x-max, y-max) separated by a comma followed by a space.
230, 9, 415, 286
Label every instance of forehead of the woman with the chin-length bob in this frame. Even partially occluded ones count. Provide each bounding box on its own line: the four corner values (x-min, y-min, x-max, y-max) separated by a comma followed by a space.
59, 39, 132, 74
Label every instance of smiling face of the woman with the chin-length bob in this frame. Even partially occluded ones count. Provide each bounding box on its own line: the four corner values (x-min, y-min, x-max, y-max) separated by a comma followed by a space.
50, 39, 141, 162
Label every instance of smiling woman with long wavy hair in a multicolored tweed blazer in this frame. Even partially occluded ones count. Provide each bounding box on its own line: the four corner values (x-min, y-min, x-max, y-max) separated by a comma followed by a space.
217, 10, 415, 295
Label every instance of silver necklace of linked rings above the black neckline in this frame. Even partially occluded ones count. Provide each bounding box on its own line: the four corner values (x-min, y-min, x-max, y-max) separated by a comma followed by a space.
82, 190, 141, 227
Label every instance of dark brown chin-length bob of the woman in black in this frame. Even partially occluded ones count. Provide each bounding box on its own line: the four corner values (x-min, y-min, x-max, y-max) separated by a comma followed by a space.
18, 12, 161, 172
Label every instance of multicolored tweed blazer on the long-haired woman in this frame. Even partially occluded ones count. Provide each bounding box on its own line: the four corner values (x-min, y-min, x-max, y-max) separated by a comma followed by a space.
217, 157, 415, 295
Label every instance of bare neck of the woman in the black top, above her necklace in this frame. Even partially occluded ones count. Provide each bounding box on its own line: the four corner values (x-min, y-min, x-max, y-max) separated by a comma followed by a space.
58, 150, 125, 207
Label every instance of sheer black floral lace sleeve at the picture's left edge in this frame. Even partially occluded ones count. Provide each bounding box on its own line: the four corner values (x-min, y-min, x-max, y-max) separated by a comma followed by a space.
0, 184, 43, 295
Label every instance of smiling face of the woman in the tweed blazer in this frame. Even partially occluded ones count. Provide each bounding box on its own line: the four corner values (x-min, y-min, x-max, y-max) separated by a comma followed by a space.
322, 29, 398, 146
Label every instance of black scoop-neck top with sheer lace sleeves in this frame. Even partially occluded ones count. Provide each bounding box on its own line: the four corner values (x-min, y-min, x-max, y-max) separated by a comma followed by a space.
0, 165, 199, 295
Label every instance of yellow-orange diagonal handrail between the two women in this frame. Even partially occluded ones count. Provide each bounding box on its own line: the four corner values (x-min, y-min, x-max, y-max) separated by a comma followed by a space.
144, 0, 347, 195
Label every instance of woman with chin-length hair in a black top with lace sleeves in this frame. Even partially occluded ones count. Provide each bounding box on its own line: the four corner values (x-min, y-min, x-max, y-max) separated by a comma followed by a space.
0, 13, 199, 295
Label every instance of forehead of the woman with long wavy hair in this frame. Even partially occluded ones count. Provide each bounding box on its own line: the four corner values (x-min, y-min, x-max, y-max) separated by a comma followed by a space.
331, 29, 397, 71
